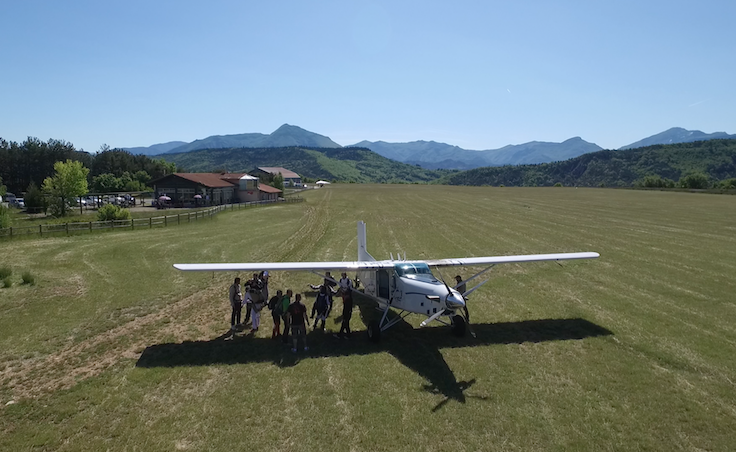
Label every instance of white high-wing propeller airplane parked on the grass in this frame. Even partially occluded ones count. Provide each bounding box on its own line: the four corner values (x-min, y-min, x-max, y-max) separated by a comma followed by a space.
174, 221, 600, 342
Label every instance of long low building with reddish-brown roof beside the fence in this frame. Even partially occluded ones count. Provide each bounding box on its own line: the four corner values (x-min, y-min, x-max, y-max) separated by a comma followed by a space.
152, 173, 281, 206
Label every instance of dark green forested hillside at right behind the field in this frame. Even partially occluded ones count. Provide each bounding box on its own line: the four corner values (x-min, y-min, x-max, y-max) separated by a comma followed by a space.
438, 140, 736, 187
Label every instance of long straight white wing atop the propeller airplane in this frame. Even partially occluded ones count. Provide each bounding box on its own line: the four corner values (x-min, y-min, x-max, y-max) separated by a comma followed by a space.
174, 253, 599, 272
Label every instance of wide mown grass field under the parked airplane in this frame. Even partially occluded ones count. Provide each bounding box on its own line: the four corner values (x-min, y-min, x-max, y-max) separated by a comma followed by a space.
0, 184, 736, 451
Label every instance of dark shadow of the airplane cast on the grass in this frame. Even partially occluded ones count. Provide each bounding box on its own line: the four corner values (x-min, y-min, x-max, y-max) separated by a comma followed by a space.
136, 294, 613, 411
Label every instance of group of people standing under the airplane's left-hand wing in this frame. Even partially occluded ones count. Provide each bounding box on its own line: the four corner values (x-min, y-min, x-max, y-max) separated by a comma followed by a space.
230, 271, 354, 353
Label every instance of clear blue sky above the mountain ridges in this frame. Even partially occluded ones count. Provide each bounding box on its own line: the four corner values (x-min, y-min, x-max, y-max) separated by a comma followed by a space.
0, 0, 736, 151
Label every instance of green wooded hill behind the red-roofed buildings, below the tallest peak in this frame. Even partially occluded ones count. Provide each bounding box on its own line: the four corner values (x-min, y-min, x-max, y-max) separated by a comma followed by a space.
159, 147, 452, 183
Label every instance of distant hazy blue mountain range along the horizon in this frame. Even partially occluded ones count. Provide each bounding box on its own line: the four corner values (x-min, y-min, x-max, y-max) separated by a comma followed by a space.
124, 124, 736, 170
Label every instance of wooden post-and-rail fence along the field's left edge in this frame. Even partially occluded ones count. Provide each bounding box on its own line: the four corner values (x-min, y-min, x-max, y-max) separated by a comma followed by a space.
0, 196, 304, 238
